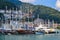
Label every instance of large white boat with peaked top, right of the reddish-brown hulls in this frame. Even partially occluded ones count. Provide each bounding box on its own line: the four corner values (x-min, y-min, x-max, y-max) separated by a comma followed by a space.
35, 24, 58, 34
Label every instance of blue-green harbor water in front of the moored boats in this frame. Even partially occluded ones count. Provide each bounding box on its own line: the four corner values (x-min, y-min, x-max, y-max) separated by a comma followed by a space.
0, 33, 60, 40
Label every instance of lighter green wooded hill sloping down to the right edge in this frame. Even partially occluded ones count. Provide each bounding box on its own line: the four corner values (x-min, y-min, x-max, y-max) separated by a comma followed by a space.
21, 3, 60, 23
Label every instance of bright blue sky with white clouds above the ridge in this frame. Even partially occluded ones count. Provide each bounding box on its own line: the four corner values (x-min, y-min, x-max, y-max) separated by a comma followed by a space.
20, 0, 60, 11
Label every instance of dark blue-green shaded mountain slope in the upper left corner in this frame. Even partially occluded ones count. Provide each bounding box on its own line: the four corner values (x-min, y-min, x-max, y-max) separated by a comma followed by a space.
0, 0, 22, 10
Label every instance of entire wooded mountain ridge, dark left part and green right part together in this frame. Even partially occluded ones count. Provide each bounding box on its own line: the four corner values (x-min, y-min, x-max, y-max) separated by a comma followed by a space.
0, 0, 60, 23
